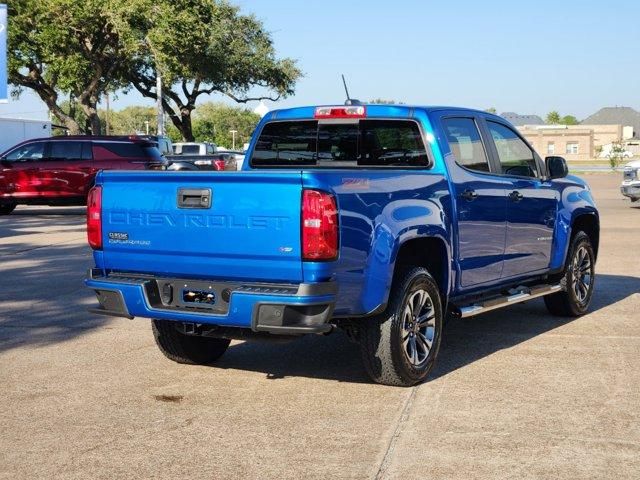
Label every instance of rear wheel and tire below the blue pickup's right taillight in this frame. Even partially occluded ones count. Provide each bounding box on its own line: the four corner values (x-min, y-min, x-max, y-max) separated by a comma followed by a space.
360, 267, 443, 387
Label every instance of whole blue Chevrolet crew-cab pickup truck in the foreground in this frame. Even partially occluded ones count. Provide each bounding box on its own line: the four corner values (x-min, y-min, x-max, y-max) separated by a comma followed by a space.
86, 104, 599, 386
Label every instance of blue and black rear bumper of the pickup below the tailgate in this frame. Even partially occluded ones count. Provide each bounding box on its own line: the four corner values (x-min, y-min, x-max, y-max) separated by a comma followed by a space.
85, 269, 337, 335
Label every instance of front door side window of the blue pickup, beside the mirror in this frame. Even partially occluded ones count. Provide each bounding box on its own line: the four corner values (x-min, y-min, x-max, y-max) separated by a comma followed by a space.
487, 120, 540, 177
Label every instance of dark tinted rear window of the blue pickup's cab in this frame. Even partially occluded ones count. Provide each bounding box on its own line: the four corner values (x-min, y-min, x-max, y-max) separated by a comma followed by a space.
251, 120, 429, 168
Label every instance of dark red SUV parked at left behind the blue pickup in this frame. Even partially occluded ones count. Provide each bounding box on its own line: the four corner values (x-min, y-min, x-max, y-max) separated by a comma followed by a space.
0, 136, 162, 215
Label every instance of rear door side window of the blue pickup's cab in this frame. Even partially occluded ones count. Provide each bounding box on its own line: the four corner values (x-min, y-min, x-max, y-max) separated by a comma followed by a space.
442, 118, 489, 173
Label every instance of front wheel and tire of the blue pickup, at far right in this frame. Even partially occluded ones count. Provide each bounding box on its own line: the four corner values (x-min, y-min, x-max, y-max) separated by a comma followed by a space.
544, 231, 596, 317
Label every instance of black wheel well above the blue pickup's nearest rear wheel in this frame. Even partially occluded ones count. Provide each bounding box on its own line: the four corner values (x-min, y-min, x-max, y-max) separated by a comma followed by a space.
394, 237, 449, 298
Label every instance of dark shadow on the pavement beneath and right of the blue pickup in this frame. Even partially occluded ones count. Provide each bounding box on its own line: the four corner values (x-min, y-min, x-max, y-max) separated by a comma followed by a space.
215, 274, 640, 382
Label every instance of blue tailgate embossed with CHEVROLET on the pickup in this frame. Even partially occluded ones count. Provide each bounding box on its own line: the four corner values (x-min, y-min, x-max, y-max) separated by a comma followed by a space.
97, 171, 302, 282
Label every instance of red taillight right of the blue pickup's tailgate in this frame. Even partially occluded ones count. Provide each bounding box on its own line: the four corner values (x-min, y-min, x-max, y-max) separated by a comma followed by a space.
302, 190, 338, 261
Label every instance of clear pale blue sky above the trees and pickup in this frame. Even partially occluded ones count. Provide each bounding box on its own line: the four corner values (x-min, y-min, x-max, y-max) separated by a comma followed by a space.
0, 0, 640, 119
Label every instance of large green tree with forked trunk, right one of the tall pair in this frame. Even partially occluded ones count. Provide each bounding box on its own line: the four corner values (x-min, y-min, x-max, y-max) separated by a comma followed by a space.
127, 0, 301, 140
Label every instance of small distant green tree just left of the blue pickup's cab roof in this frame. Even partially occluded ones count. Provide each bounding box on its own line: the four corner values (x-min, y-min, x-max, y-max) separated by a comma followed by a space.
193, 103, 260, 148
